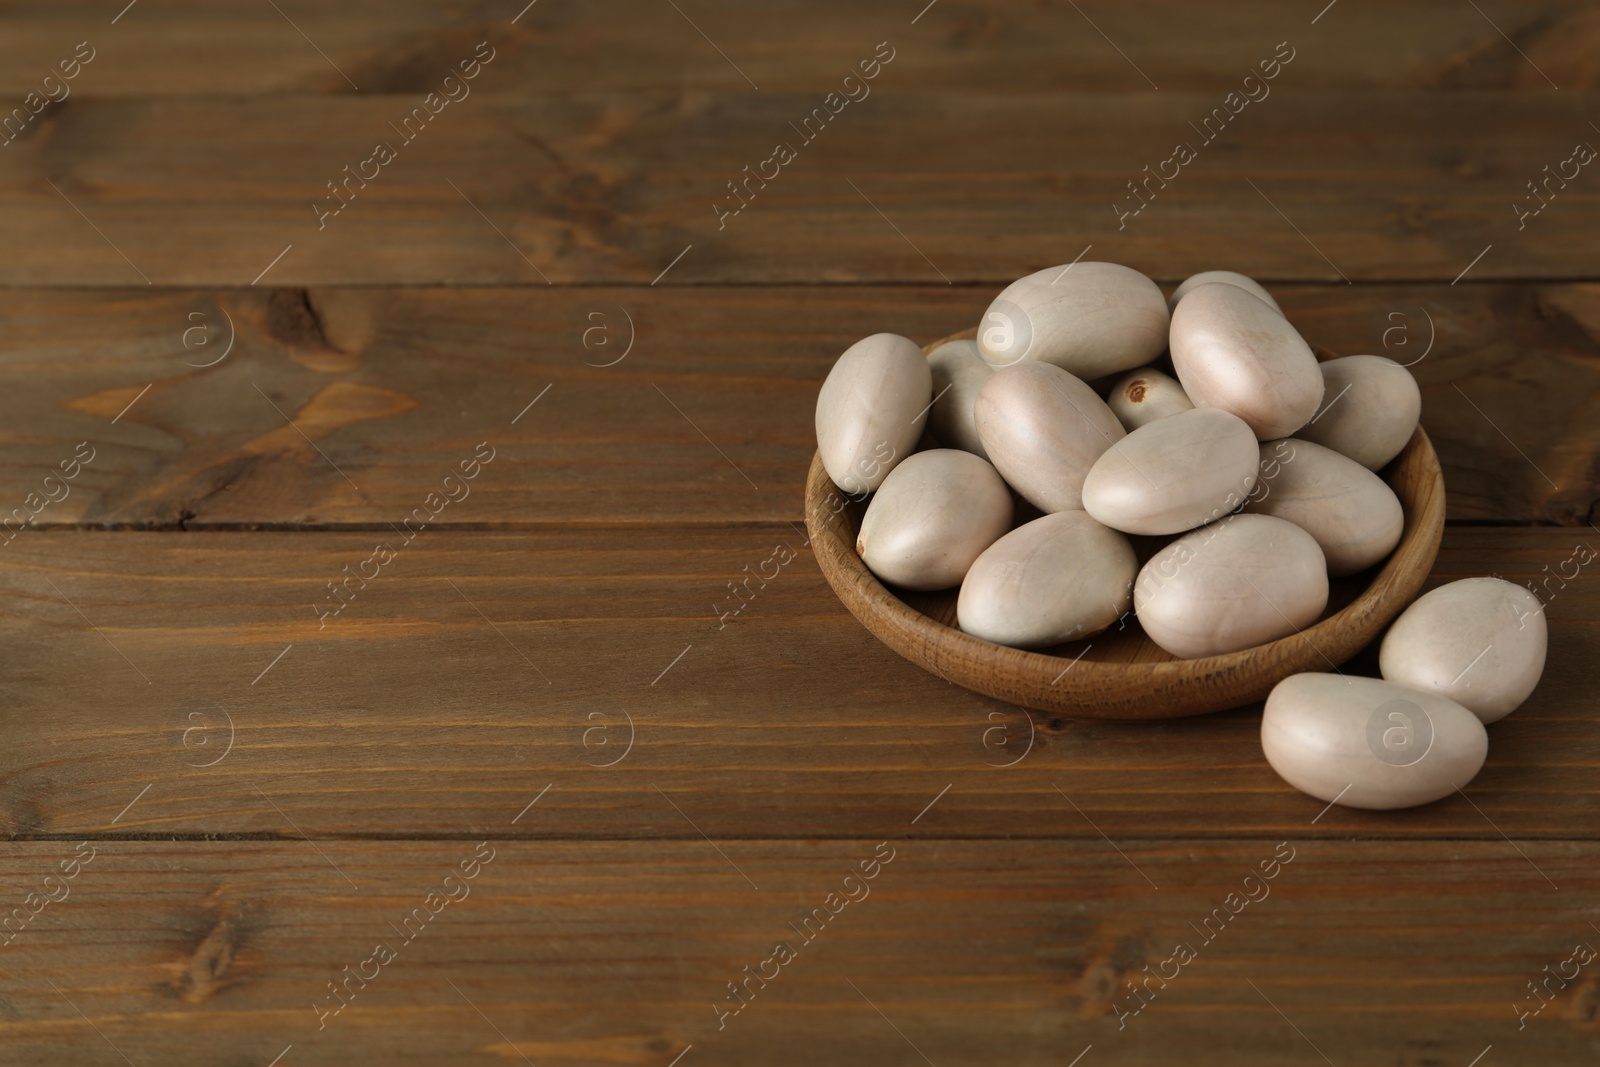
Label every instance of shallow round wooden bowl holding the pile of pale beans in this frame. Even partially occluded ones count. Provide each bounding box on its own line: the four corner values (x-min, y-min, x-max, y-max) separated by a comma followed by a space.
805, 330, 1445, 718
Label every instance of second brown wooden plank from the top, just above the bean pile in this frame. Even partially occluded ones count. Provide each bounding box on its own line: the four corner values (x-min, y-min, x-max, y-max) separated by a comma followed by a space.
0, 90, 1600, 286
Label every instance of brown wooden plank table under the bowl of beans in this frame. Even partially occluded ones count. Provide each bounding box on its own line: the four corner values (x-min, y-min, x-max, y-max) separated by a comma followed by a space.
0, 0, 1600, 1067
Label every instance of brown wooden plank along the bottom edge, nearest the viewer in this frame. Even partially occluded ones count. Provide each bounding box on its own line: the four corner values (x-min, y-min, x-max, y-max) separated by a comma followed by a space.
0, 844, 1600, 1067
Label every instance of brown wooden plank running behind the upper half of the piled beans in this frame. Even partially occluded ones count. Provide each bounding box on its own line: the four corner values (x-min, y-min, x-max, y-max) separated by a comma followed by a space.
0, 283, 1600, 536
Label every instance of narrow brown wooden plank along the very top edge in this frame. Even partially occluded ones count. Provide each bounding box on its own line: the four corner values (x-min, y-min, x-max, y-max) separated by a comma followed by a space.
0, 0, 1600, 99
